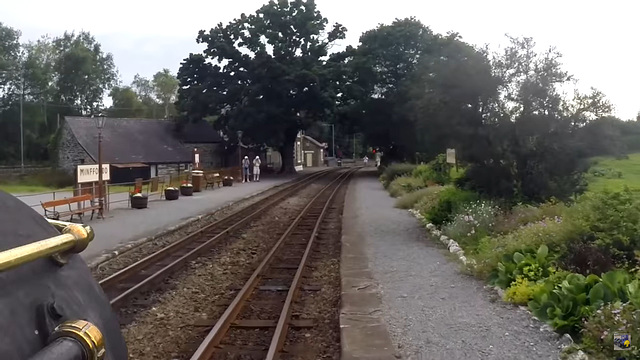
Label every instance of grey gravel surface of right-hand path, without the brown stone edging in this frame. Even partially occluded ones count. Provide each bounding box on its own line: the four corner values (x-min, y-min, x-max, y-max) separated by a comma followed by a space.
351, 177, 560, 360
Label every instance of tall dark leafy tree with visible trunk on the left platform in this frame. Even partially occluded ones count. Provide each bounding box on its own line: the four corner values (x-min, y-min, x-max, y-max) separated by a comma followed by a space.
177, 0, 346, 172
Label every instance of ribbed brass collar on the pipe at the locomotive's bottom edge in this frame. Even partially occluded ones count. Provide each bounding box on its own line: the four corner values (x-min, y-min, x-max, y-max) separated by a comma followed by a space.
49, 320, 106, 360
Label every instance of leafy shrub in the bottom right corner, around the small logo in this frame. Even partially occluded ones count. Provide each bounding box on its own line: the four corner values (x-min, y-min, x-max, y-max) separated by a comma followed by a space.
581, 301, 640, 359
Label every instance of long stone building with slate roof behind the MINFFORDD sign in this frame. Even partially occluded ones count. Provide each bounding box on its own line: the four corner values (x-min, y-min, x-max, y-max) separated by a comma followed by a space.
58, 116, 222, 183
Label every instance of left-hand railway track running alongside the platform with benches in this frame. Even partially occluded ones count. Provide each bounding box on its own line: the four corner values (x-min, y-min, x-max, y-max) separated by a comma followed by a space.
99, 170, 335, 308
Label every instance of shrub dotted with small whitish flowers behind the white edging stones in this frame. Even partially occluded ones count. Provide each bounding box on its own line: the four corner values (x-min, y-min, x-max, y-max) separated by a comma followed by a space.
442, 200, 498, 250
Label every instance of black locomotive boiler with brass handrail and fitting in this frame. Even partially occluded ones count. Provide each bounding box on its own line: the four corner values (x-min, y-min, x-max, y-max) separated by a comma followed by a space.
0, 191, 127, 360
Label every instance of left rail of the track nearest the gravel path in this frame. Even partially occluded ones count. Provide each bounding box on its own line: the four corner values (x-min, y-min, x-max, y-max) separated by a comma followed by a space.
191, 168, 358, 360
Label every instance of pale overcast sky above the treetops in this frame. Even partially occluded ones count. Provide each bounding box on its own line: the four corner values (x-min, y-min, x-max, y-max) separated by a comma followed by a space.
0, 0, 640, 120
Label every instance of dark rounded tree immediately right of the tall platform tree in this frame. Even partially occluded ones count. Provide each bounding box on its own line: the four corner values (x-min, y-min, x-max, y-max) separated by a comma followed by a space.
333, 18, 441, 161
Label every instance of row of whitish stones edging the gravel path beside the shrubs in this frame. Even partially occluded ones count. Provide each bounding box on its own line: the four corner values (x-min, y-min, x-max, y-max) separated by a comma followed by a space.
409, 209, 590, 360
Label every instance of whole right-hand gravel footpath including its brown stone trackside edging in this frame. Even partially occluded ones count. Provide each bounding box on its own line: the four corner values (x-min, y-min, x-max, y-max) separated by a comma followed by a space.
340, 169, 561, 360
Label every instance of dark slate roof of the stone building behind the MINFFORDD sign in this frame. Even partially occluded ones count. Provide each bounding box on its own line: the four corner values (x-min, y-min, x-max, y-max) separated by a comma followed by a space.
65, 116, 191, 164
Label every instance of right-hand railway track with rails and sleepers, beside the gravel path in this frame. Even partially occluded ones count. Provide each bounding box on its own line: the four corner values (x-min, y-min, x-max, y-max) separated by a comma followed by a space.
191, 168, 358, 360
